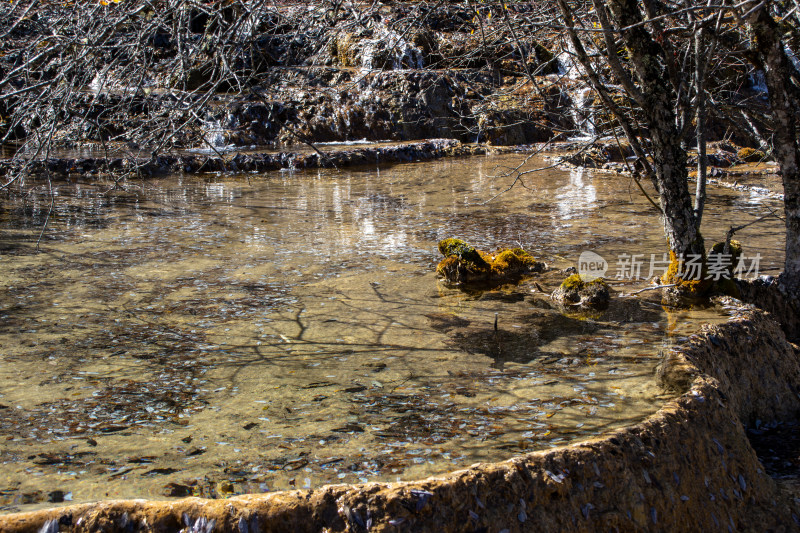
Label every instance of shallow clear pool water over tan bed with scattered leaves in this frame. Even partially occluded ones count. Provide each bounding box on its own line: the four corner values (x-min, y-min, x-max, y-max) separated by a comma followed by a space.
0, 155, 782, 511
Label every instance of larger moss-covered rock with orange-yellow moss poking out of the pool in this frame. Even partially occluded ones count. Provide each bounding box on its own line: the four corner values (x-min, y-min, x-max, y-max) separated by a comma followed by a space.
436, 238, 547, 285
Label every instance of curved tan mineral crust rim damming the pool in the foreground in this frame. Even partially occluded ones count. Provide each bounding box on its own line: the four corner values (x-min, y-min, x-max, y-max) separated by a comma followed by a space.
0, 307, 800, 533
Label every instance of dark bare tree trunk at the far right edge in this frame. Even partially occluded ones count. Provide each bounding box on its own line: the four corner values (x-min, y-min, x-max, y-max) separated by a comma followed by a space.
750, 7, 800, 297
